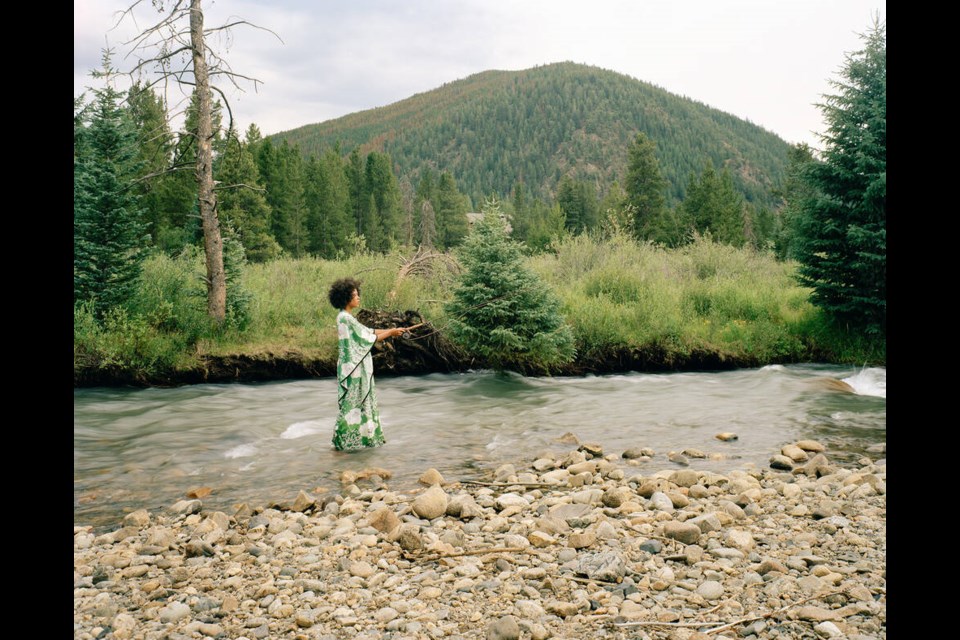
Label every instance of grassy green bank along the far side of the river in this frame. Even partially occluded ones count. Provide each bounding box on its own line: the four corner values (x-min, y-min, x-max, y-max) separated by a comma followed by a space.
74, 236, 886, 381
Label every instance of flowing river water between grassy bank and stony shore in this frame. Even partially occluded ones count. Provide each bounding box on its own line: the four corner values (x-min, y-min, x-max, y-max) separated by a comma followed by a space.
73, 364, 887, 530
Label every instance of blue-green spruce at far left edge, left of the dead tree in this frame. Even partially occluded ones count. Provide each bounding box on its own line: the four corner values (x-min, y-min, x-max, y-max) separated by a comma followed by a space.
73, 52, 147, 318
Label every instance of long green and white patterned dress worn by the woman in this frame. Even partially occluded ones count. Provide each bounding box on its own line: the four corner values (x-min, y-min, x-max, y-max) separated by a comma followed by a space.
333, 311, 386, 451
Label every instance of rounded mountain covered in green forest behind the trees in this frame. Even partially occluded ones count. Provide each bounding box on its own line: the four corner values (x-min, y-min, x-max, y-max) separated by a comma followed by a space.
269, 62, 790, 208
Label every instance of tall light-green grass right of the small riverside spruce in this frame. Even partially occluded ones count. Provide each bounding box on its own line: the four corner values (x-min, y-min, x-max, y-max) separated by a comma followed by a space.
530, 235, 867, 362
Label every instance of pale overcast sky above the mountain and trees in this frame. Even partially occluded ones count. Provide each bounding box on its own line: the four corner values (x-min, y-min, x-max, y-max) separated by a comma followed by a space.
73, 0, 886, 148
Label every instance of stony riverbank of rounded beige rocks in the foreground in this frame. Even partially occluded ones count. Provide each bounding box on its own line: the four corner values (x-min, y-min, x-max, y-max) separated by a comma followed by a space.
74, 434, 886, 640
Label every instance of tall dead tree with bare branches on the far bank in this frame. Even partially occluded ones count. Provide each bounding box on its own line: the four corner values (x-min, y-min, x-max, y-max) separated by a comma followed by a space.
117, 0, 282, 324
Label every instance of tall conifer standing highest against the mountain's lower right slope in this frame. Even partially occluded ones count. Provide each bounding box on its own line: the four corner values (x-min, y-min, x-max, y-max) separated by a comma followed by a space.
625, 132, 667, 240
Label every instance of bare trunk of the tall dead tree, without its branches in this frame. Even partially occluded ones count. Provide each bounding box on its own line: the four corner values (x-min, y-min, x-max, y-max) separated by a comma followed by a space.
190, 0, 227, 324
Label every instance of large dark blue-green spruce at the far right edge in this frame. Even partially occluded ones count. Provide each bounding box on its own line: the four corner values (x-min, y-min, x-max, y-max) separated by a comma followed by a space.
797, 20, 887, 335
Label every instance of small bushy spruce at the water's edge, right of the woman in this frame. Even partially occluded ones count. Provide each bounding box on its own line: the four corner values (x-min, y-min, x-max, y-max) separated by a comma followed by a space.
446, 202, 574, 371
